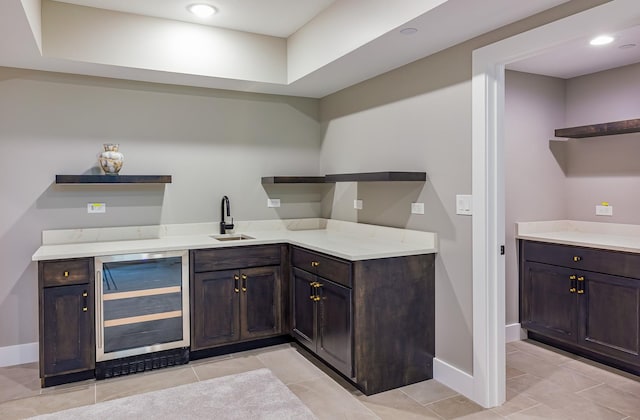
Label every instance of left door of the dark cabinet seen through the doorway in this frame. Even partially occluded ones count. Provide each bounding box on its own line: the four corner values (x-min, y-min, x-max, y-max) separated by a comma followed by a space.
520, 262, 578, 342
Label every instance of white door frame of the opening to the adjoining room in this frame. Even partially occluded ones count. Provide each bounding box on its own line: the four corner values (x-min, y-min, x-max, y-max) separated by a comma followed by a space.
470, 0, 640, 407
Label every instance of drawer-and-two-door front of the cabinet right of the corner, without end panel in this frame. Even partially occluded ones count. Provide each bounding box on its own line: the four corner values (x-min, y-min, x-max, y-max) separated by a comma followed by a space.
291, 247, 353, 377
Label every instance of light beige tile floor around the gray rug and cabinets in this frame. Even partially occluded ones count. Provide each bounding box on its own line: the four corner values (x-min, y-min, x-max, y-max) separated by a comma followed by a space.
0, 341, 640, 420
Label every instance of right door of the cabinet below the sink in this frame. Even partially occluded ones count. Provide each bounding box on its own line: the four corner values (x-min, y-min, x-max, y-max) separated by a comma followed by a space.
240, 267, 282, 340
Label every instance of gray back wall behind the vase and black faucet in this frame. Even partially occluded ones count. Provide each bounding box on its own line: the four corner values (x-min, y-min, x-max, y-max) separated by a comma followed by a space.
0, 68, 322, 347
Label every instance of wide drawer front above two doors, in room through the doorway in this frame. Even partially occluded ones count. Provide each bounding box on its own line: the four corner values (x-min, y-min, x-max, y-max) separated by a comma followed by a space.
521, 241, 640, 278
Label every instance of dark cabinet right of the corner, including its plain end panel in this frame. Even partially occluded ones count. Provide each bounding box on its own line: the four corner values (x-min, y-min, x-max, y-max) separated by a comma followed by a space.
291, 247, 435, 395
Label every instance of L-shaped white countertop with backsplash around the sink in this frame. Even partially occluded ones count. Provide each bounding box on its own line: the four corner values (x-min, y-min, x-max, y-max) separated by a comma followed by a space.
32, 219, 438, 261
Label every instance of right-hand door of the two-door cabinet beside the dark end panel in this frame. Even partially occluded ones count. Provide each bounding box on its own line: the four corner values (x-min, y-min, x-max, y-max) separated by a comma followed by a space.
316, 277, 353, 377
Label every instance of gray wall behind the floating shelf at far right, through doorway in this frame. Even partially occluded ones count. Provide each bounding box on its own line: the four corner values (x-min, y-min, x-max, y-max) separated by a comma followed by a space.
566, 64, 640, 224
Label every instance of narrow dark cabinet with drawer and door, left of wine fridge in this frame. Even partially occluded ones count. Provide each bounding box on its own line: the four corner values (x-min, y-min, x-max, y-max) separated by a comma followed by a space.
38, 258, 95, 386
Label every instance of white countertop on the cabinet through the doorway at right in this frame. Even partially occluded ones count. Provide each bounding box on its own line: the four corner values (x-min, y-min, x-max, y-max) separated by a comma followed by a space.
516, 220, 640, 253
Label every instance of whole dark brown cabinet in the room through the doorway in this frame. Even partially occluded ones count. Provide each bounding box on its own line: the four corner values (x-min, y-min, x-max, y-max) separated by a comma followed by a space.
520, 240, 640, 373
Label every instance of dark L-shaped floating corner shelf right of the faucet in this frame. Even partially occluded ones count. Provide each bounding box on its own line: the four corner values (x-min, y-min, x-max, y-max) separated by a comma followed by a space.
262, 172, 427, 184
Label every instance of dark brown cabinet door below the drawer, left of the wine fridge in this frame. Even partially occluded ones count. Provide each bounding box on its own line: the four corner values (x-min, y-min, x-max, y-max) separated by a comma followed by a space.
41, 284, 95, 376
